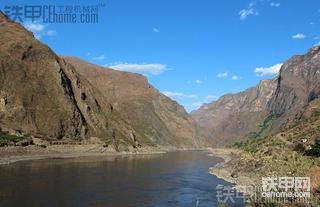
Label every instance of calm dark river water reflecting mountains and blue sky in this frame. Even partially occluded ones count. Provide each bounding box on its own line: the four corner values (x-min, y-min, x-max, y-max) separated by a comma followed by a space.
0, 151, 243, 207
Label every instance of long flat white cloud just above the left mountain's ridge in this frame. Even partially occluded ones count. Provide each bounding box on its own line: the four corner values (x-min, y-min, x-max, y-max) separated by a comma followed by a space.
105, 63, 168, 75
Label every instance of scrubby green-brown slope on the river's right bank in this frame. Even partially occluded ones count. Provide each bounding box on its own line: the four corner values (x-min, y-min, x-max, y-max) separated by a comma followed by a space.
233, 110, 320, 206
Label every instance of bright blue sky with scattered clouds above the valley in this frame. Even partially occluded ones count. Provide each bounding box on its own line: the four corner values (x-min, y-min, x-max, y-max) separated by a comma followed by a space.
0, 0, 320, 111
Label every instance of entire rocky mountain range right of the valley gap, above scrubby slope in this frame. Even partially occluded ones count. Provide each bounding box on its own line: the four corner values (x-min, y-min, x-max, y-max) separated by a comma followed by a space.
191, 46, 320, 145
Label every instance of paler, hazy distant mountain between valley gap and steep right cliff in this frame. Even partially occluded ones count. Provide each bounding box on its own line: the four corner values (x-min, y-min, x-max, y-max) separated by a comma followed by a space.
191, 80, 276, 146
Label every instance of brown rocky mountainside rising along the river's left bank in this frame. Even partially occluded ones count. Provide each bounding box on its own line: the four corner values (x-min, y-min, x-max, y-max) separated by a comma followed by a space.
0, 13, 203, 150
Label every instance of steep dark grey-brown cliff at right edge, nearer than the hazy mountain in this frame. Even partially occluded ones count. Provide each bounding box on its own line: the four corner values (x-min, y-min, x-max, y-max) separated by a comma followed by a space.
268, 46, 320, 129
